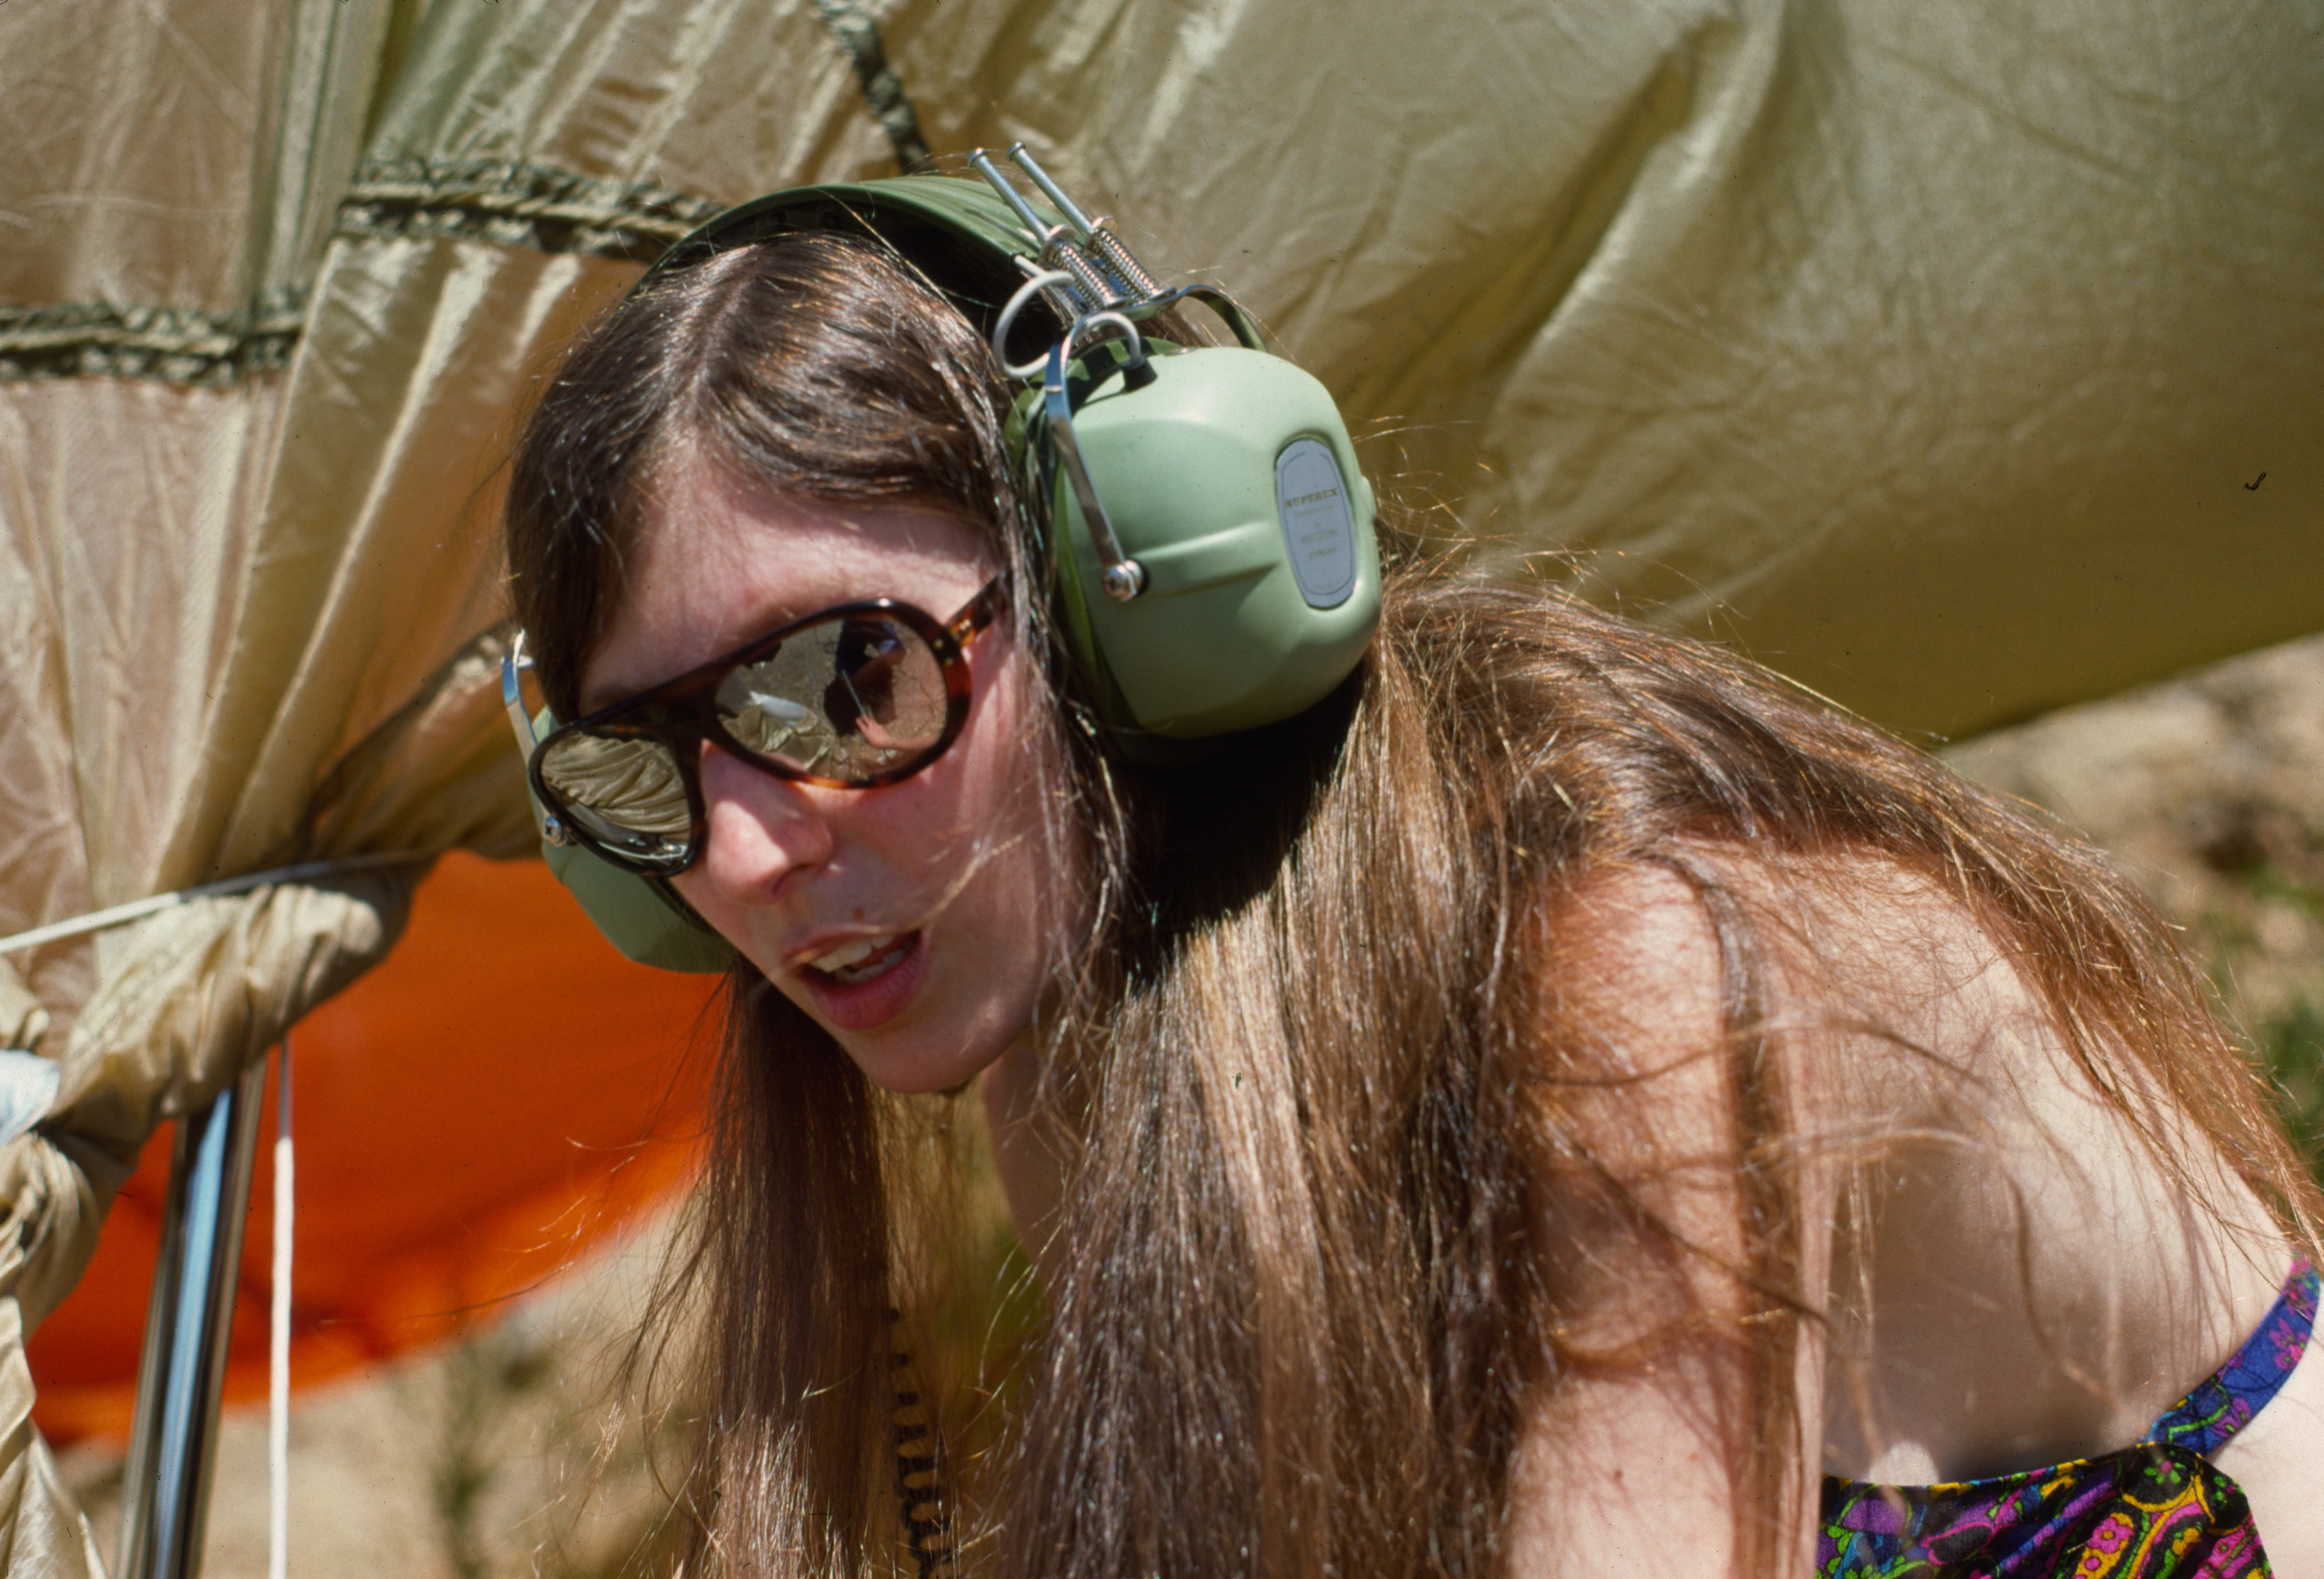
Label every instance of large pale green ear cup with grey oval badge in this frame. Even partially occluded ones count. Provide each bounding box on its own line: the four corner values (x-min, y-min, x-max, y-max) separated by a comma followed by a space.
1011, 342, 1380, 749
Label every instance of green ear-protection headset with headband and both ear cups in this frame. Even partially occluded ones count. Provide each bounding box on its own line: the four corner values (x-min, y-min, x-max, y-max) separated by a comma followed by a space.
502, 147, 1380, 970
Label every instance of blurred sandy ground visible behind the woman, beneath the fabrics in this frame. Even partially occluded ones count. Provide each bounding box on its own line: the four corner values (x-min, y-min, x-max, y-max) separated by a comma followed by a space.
65, 637, 2324, 1579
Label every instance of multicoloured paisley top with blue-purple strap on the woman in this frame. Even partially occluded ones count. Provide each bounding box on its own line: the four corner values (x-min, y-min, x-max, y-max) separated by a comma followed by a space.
1815, 1263, 2320, 1579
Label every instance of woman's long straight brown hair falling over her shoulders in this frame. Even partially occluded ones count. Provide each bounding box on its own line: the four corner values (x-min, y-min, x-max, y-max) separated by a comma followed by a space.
507, 235, 2315, 1579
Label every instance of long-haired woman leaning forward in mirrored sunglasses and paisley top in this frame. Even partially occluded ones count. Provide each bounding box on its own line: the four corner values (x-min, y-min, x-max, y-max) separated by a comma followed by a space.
507, 179, 2324, 1579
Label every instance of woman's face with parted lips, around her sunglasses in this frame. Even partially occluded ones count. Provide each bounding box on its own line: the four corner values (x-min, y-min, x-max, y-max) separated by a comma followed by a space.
581, 458, 1080, 1090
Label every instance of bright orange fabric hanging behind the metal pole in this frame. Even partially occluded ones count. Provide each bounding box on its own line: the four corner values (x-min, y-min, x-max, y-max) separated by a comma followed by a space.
30, 851, 714, 1442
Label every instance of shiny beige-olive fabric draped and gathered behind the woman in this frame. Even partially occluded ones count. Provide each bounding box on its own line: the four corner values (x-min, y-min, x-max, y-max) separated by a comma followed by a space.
0, 0, 2324, 1575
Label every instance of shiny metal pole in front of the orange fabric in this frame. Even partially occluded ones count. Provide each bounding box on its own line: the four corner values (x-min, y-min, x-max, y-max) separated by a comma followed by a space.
116, 1058, 267, 1579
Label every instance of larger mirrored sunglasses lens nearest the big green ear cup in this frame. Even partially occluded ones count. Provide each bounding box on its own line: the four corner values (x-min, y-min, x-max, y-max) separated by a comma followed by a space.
716, 614, 948, 783
